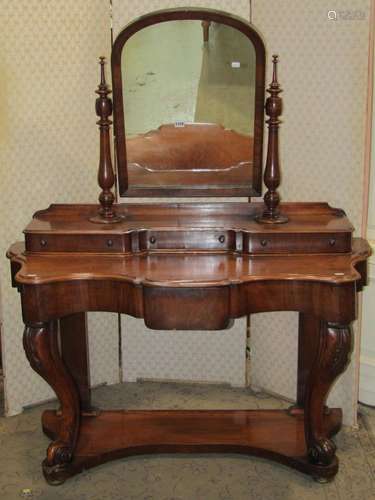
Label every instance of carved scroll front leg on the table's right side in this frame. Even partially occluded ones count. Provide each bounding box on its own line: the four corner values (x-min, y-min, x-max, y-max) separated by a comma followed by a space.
305, 321, 352, 477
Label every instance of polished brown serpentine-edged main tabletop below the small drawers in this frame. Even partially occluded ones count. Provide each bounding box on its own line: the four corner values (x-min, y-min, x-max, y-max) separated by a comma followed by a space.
8, 238, 370, 287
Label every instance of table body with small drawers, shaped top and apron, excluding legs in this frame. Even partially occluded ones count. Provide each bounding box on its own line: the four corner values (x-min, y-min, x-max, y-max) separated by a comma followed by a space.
8, 203, 370, 330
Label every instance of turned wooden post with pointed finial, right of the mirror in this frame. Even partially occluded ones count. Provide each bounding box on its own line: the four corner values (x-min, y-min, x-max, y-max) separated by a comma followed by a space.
256, 55, 288, 224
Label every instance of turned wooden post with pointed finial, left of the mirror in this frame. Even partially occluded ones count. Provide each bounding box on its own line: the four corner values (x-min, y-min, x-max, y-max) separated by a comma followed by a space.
90, 57, 121, 224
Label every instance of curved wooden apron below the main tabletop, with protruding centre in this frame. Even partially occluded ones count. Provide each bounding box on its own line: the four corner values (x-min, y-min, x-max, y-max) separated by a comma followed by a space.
19, 278, 357, 330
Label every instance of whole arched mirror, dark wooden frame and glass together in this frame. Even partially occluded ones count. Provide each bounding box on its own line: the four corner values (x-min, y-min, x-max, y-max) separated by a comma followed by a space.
112, 9, 265, 197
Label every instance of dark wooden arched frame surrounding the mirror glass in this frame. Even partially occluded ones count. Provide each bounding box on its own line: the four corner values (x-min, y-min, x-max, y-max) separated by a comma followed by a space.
111, 8, 266, 197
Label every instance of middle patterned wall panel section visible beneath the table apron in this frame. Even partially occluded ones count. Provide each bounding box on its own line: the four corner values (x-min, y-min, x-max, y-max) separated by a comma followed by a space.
123, 316, 246, 387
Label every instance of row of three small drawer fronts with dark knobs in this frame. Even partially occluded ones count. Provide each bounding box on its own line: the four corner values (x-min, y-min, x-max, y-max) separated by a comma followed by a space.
26, 228, 351, 254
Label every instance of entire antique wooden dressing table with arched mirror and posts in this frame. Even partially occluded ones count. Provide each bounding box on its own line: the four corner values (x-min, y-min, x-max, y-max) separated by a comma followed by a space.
8, 9, 370, 484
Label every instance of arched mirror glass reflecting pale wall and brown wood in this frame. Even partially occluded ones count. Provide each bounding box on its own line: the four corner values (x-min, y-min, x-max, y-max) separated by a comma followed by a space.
121, 20, 256, 189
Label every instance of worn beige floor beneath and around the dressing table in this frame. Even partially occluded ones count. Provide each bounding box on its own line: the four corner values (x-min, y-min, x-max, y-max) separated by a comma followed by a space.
0, 382, 375, 500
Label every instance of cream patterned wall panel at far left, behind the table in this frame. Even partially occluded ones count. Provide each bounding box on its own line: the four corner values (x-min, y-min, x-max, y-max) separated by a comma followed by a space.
0, 0, 118, 415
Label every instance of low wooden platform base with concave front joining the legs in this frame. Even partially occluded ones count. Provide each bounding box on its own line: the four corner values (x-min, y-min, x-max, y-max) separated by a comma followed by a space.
42, 409, 342, 484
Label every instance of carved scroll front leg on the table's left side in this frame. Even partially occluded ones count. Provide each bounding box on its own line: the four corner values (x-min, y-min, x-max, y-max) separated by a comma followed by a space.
23, 321, 80, 484
